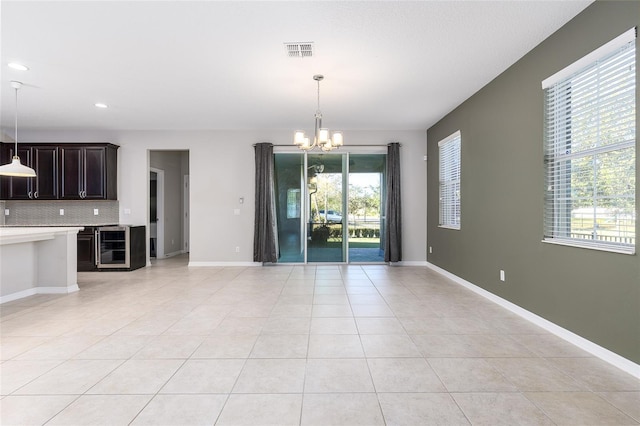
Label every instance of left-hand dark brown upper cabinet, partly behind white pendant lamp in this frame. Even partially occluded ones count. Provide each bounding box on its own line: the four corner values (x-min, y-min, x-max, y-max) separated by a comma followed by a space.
0, 145, 58, 200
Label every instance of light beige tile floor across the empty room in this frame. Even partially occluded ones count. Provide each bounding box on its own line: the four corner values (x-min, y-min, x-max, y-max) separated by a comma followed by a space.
0, 256, 640, 426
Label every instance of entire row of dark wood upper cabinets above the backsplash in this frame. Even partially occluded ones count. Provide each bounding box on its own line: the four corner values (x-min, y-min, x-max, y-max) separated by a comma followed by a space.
0, 143, 118, 200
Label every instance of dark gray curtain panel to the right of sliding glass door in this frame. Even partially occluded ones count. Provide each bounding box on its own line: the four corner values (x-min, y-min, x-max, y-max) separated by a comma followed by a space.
384, 142, 402, 262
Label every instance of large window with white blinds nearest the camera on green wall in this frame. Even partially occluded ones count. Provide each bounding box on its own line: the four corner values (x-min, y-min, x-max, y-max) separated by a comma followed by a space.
543, 29, 636, 253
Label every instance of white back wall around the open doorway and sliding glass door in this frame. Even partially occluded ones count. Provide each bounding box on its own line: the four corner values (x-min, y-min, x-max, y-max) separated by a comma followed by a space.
21, 130, 427, 263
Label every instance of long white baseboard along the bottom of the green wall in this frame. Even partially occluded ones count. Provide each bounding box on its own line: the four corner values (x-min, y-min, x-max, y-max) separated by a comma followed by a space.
427, 262, 640, 379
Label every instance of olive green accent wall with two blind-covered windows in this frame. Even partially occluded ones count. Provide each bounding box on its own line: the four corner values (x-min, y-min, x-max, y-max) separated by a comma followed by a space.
426, 1, 640, 363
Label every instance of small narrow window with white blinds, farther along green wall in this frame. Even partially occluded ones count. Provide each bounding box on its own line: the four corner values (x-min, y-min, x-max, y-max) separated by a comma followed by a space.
438, 131, 461, 229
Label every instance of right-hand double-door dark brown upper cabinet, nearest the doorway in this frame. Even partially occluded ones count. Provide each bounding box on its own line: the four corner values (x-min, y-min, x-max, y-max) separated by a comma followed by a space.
59, 144, 118, 200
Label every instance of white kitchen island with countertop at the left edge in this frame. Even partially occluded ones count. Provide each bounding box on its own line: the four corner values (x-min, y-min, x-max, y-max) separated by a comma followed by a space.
0, 227, 83, 303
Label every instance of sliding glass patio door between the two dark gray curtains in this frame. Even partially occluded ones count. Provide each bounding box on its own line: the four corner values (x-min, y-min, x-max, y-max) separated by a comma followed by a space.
275, 153, 386, 263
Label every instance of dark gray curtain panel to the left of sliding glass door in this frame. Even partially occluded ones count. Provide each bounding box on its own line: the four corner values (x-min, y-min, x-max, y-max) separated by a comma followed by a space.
253, 143, 278, 263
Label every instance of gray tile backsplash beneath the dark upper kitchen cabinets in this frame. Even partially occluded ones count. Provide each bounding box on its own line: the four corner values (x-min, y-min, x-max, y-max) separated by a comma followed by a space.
0, 200, 120, 226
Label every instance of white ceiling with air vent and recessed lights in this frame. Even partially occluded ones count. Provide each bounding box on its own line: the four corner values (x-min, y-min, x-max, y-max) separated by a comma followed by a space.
0, 0, 591, 134
